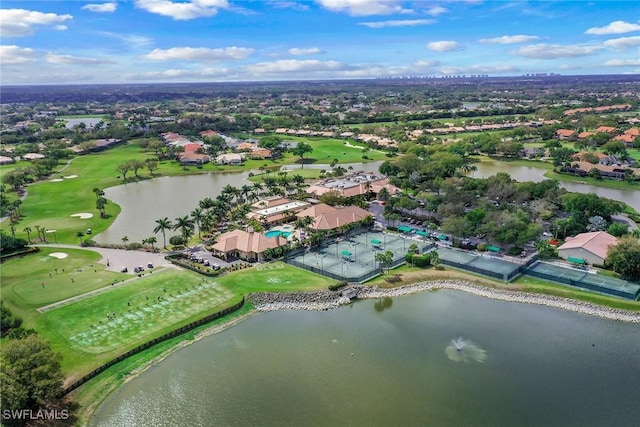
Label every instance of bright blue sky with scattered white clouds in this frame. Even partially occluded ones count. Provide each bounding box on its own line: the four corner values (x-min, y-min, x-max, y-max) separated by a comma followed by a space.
0, 0, 640, 85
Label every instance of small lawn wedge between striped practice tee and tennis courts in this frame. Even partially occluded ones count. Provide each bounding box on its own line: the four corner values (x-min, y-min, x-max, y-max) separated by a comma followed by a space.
216, 262, 335, 295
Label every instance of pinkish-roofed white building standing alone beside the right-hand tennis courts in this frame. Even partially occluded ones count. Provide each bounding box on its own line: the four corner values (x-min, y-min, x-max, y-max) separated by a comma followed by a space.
558, 231, 618, 265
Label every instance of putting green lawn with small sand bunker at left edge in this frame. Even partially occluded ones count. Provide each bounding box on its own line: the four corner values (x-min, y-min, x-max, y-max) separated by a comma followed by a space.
1, 247, 125, 312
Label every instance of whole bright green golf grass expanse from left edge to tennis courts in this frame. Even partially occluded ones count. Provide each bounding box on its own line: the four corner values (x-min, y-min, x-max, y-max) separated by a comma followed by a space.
1, 248, 332, 378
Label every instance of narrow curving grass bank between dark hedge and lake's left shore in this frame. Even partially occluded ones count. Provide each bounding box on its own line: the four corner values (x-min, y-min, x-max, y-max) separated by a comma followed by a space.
69, 303, 253, 425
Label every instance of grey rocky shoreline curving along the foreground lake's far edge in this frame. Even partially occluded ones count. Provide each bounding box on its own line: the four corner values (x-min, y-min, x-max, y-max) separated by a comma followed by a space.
247, 280, 640, 323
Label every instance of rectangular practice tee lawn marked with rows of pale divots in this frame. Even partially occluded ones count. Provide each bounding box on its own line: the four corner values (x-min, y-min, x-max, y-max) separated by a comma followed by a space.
36, 269, 240, 376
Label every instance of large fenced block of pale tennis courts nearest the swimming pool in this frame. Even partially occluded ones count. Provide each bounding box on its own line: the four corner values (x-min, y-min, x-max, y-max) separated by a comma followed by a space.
286, 231, 427, 282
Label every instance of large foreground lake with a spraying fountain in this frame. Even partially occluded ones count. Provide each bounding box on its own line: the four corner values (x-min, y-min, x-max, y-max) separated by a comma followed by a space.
91, 290, 640, 427
